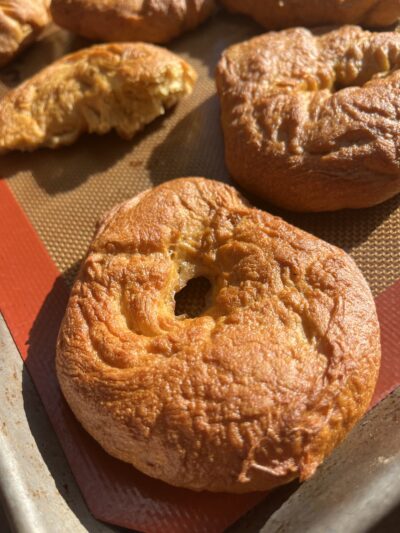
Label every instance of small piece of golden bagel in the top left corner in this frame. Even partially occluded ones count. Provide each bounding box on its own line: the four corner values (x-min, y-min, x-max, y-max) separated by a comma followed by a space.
0, 0, 50, 67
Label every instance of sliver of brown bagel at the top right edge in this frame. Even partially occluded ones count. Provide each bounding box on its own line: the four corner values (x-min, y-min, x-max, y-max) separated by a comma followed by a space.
221, 0, 400, 30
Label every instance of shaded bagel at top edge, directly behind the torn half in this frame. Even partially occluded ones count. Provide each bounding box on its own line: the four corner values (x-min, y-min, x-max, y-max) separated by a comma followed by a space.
51, 0, 214, 43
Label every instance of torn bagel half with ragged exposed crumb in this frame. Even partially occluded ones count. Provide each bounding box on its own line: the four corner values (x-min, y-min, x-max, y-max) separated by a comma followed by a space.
0, 43, 197, 152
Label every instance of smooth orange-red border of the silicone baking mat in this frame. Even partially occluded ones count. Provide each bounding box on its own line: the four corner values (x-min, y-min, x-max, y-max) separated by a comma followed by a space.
0, 181, 400, 533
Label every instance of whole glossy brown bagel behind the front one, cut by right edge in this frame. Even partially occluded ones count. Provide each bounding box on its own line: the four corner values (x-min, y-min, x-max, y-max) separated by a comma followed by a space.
217, 26, 400, 211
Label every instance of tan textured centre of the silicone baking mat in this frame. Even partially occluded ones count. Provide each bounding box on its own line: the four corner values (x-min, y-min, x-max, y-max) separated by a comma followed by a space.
0, 13, 400, 294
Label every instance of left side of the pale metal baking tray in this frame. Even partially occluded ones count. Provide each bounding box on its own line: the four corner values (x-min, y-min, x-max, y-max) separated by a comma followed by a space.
0, 315, 116, 533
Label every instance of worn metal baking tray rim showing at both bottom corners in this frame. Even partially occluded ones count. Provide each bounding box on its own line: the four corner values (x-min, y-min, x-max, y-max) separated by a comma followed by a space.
0, 310, 400, 533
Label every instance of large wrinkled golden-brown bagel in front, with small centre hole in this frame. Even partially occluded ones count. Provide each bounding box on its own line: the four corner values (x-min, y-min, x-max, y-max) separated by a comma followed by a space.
56, 178, 380, 493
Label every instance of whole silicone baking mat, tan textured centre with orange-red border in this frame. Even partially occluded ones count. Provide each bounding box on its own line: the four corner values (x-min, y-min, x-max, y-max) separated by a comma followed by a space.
0, 14, 400, 533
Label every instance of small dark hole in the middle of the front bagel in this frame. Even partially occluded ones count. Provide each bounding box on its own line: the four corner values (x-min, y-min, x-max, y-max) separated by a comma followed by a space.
175, 276, 212, 318
